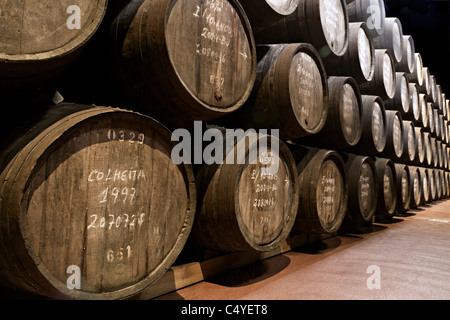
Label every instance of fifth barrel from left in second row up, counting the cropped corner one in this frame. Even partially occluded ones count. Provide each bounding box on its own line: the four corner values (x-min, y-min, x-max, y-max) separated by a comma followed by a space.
349, 95, 387, 155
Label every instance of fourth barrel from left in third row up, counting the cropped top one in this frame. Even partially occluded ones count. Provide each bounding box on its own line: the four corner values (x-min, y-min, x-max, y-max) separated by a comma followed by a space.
360, 49, 396, 100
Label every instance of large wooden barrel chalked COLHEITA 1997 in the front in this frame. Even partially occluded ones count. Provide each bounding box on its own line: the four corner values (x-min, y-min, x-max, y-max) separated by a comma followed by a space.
0, 104, 196, 299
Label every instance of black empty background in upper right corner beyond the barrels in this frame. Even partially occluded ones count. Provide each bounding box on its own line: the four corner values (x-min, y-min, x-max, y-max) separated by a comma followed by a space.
385, 0, 450, 94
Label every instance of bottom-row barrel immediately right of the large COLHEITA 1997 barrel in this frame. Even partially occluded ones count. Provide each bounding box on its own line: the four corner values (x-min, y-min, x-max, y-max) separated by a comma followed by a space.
192, 129, 299, 252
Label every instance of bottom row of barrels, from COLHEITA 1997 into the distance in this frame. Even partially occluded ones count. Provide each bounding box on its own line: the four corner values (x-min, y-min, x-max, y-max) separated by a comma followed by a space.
0, 104, 450, 299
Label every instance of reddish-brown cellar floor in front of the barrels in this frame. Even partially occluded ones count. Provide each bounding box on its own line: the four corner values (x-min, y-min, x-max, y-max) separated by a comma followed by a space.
157, 200, 450, 300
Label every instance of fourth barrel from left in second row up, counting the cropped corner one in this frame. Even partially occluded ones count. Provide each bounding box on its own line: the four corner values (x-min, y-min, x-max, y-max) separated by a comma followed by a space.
298, 77, 362, 150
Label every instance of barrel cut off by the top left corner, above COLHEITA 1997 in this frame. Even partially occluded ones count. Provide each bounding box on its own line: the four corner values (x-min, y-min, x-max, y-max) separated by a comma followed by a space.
0, 0, 108, 104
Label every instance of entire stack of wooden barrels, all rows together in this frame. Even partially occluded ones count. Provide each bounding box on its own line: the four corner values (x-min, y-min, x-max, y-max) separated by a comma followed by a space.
0, 0, 450, 299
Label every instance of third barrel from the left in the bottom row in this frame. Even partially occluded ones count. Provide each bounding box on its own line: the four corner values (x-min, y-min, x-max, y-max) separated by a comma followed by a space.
293, 148, 348, 233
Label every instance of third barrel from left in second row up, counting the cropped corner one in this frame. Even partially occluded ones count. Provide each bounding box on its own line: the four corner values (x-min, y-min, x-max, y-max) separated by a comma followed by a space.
223, 44, 328, 139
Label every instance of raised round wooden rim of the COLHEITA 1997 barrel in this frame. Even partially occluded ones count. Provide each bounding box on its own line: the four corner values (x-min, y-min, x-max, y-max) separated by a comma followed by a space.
2, 104, 196, 299
